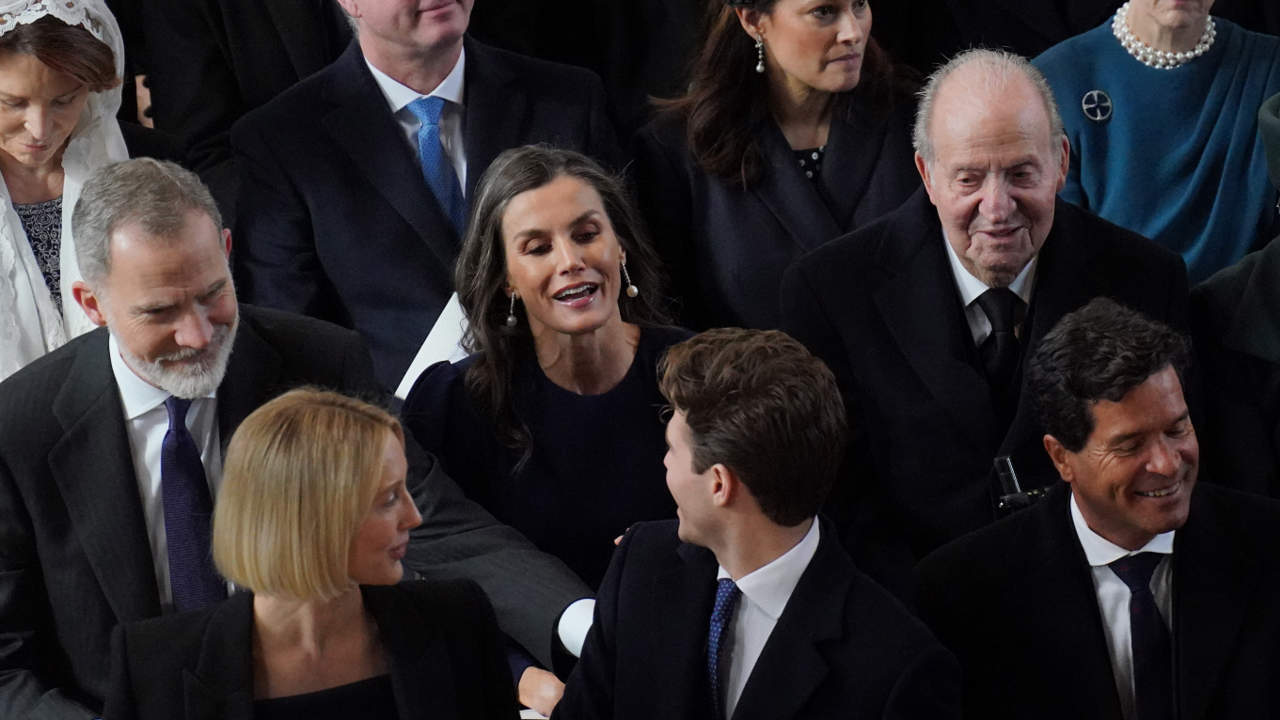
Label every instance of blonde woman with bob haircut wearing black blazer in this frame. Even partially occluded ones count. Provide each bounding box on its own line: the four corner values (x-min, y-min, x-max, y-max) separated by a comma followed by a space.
104, 388, 516, 720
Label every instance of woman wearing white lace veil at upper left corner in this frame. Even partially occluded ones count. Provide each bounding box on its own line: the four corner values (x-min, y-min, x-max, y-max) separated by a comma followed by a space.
0, 0, 128, 379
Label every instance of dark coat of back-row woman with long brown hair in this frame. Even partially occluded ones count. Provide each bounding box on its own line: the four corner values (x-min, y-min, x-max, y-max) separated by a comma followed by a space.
634, 94, 920, 329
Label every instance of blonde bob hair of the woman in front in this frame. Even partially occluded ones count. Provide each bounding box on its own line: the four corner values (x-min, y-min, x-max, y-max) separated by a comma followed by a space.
212, 388, 404, 600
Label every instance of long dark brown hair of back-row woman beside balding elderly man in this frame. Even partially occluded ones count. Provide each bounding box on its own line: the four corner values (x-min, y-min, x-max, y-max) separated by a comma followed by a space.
657, 0, 918, 188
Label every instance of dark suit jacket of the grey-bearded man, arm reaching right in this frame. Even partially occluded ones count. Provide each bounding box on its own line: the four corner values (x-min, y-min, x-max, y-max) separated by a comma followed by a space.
0, 305, 589, 719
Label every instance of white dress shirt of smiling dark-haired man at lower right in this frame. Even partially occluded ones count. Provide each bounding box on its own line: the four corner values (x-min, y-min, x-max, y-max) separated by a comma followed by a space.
1071, 495, 1176, 720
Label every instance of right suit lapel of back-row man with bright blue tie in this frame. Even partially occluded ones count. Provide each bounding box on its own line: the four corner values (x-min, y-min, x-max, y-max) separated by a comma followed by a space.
462, 37, 529, 198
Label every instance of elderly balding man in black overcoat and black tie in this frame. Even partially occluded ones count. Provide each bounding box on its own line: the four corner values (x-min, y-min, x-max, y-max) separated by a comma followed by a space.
782, 43, 1187, 594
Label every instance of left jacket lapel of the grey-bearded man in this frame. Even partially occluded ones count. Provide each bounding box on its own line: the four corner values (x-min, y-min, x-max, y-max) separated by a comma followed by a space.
49, 331, 160, 621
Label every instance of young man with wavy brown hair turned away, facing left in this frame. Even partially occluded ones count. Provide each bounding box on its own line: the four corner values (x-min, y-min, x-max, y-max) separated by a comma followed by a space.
553, 328, 959, 720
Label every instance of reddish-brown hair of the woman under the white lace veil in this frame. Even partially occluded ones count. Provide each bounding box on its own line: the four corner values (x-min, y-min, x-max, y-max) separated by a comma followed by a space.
0, 15, 120, 92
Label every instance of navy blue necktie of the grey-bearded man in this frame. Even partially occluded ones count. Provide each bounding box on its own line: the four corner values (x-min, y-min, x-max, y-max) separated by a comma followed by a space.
160, 396, 227, 612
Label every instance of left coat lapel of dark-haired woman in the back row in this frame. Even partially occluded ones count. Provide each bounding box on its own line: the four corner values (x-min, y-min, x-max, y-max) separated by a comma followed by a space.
751, 120, 845, 250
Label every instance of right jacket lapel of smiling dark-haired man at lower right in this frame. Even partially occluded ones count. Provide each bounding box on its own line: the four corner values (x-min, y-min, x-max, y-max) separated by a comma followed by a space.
1174, 493, 1261, 720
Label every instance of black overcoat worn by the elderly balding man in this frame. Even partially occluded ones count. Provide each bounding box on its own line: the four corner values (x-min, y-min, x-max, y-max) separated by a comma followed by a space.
782, 190, 1187, 593
